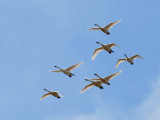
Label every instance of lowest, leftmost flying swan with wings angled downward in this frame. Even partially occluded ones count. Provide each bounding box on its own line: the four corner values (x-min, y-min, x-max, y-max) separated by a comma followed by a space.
40, 89, 63, 100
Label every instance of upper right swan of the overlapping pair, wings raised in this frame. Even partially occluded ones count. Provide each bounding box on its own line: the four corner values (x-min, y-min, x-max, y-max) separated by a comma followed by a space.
89, 70, 122, 85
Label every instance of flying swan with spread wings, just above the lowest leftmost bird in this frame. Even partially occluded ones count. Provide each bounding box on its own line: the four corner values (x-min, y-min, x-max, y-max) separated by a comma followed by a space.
50, 62, 83, 77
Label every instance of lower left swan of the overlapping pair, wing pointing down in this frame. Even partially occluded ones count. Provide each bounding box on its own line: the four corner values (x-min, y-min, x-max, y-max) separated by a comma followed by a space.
80, 79, 104, 93
